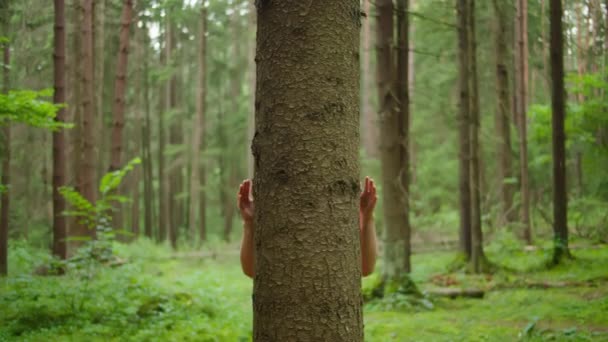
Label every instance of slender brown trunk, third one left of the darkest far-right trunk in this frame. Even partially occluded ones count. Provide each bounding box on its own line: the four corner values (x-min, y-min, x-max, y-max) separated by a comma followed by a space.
468, 0, 486, 273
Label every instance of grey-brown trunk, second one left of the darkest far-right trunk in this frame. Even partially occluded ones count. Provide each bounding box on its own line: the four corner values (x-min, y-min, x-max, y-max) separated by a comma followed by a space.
492, 0, 515, 223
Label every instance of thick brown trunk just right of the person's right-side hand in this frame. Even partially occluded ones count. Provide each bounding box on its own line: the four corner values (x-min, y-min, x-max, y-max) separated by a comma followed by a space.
377, 0, 411, 283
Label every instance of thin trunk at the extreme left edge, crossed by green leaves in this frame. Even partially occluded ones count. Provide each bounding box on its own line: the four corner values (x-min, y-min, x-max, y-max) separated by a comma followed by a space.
0, 0, 11, 275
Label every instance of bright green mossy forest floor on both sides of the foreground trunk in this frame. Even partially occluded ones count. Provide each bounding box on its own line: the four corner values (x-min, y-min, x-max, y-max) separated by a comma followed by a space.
0, 241, 608, 342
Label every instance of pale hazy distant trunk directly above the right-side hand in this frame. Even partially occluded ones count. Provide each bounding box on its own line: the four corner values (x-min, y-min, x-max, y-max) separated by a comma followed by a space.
361, 0, 378, 158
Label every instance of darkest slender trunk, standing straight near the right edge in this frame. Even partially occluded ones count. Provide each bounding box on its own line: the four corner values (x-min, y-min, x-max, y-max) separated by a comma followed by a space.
550, 0, 570, 264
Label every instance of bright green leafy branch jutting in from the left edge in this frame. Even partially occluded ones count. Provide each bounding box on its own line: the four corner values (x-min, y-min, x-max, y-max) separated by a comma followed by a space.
0, 89, 71, 130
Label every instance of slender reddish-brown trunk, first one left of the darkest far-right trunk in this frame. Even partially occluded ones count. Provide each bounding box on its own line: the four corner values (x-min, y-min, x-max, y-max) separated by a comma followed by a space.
514, 0, 532, 244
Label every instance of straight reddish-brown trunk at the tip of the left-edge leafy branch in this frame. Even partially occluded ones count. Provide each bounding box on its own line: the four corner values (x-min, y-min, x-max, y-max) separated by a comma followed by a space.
53, 0, 68, 259
